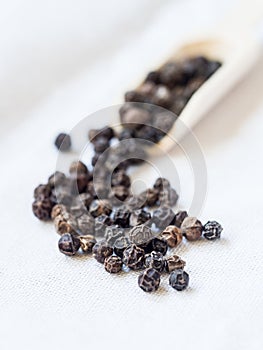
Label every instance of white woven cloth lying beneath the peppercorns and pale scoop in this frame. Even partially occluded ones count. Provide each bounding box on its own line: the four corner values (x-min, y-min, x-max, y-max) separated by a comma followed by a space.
0, 0, 263, 350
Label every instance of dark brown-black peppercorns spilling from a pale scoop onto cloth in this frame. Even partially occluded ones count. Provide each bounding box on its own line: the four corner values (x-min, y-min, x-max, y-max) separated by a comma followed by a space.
32, 57, 222, 292
